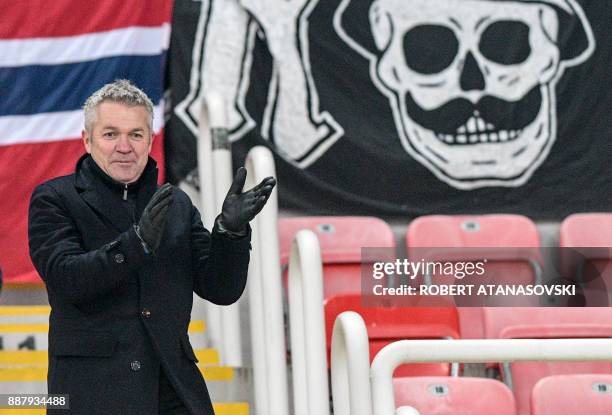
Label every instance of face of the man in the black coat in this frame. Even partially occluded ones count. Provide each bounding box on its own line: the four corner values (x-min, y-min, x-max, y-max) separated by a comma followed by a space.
82, 102, 153, 183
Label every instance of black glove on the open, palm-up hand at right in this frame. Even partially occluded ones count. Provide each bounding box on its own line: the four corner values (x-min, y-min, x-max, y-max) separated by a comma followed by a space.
220, 167, 276, 232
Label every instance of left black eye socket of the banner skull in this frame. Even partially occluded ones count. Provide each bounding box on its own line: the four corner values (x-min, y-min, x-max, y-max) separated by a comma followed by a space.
404, 25, 459, 75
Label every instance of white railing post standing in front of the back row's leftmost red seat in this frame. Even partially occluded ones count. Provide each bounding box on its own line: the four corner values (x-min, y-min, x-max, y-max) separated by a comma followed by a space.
288, 229, 329, 415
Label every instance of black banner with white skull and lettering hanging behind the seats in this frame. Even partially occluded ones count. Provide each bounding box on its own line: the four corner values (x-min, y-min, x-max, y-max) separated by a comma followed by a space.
166, 0, 612, 220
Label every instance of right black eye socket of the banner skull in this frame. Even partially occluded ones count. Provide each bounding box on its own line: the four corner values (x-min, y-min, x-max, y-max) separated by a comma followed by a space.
478, 20, 531, 65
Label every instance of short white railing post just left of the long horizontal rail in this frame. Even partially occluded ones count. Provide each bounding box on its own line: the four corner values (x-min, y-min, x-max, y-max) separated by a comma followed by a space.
331, 311, 372, 415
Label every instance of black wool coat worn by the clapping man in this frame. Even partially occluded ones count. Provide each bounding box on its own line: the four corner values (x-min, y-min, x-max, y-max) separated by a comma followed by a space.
28, 155, 250, 415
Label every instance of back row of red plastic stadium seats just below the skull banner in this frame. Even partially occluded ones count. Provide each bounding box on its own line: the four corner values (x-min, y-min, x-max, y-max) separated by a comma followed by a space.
279, 213, 612, 297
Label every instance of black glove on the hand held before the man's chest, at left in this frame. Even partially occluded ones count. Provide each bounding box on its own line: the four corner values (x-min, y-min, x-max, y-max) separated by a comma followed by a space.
136, 183, 173, 253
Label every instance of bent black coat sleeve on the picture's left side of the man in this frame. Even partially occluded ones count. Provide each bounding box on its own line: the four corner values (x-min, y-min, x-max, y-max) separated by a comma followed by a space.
28, 184, 145, 305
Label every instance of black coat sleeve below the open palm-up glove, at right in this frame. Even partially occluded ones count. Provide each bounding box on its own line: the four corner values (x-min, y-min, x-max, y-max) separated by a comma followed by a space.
191, 207, 251, 305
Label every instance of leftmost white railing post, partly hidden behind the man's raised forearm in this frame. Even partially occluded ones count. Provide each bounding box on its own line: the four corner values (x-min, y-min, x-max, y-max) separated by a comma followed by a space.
198, 91, 243, 367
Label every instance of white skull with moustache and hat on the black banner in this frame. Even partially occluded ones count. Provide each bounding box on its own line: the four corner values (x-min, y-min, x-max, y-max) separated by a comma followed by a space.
335, 0, 595, 189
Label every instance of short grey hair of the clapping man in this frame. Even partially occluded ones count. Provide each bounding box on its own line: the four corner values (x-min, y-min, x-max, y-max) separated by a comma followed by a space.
83, 79, 153, 134
